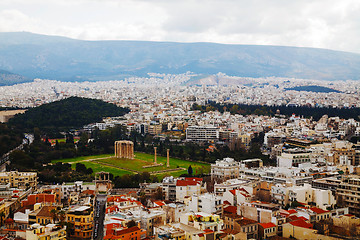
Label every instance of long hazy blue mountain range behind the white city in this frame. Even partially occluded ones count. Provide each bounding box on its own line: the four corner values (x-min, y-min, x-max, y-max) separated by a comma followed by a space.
0, 32, 360, 81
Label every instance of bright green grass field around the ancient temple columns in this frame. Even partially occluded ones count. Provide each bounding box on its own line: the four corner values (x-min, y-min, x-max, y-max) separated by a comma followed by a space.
52, 152, 210, 178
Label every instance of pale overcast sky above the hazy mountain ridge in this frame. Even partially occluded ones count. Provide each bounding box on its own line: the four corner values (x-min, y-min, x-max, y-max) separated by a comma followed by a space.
0, 0, 360, 53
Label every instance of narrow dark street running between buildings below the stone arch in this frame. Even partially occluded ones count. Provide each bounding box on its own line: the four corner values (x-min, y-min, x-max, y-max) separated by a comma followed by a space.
93, 194, 106, 240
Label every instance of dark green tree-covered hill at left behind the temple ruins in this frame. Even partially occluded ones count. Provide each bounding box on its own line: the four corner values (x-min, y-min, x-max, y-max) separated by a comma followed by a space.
9, 97, 129, 131
